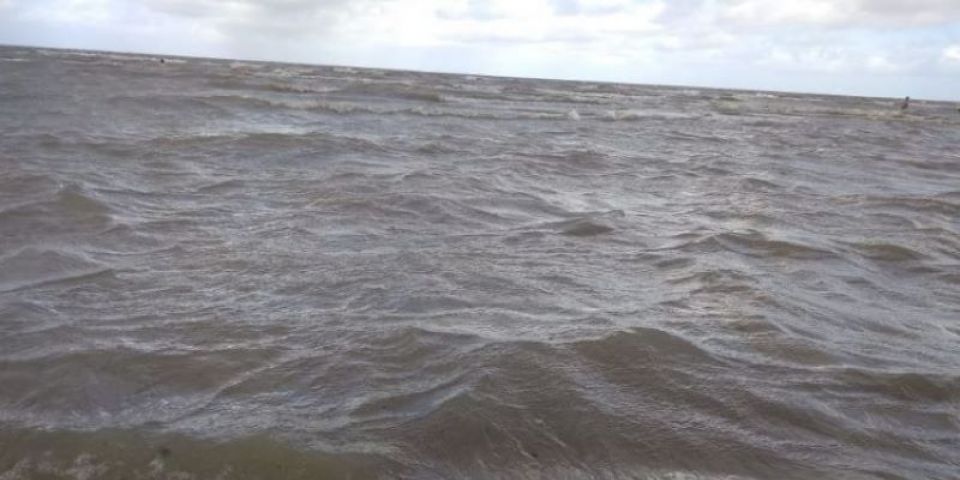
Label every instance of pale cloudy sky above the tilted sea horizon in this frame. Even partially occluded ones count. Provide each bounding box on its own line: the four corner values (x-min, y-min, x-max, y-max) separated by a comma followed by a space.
0, 0, 960, 100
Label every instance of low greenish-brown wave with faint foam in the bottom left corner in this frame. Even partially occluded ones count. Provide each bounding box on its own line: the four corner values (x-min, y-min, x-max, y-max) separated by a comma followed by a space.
0, 429, 376, 480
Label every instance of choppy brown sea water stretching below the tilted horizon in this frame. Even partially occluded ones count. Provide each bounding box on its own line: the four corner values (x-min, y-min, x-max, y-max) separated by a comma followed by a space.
0, 44, 960, 480
